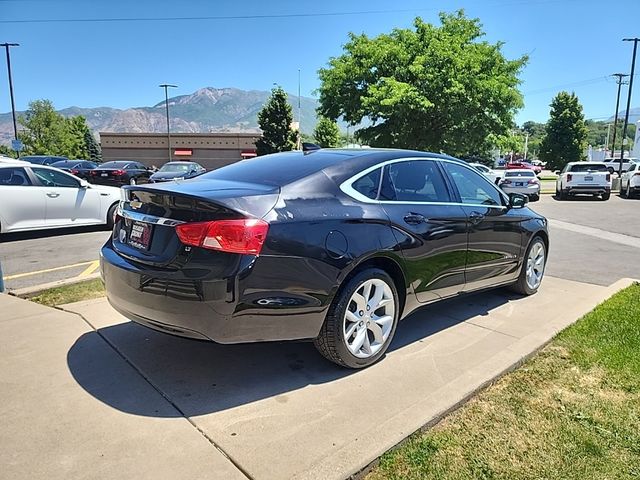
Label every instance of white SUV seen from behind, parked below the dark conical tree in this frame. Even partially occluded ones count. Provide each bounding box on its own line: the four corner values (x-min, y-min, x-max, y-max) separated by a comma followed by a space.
556, 162, 611, 200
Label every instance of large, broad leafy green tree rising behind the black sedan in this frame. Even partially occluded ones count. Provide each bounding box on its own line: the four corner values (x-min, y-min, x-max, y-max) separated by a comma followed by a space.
319, 10, 527, 156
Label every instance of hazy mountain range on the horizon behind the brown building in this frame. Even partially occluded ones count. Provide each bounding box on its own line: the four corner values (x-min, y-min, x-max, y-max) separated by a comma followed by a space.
0, 87, 318, 144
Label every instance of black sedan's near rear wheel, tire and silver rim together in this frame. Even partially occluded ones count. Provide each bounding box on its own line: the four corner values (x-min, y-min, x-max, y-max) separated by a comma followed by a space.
313, 268, 400, 369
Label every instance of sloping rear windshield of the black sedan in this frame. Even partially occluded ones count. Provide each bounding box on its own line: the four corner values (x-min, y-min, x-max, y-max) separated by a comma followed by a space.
200, 151, 351, 186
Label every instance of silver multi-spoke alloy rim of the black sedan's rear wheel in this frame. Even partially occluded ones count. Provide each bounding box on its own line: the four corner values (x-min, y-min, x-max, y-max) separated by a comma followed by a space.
342, 278, 396, 358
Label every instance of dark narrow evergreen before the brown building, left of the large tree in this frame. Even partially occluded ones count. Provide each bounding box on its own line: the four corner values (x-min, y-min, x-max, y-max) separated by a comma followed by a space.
256, 86, 298, 155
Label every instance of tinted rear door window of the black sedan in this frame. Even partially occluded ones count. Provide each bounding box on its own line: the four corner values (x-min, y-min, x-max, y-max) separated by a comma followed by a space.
380, 160, 451, 202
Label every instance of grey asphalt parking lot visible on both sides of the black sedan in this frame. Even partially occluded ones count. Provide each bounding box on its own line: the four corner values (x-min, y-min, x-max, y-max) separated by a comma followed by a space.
0, 195, 640, 290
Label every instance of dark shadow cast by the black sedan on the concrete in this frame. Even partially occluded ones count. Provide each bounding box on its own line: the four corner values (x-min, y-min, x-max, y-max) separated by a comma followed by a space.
67, 290, 518, 417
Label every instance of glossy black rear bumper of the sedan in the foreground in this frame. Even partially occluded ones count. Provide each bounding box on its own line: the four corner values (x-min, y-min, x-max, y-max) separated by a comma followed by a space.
100, 242, 331, 343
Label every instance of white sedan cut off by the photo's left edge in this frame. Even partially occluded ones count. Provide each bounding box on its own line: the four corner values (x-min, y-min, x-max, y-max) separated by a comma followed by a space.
0, 163, 120, 233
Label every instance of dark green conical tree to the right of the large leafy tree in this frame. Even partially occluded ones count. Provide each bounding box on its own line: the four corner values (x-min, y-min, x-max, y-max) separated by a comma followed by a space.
540, 92, 587, 170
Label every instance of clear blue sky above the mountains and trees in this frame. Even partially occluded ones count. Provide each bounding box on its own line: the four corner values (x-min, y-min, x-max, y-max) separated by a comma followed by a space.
0, 0, 640, 122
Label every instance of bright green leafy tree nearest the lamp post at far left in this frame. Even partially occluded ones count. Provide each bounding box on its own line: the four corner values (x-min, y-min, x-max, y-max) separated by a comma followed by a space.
19, 100, 66, 155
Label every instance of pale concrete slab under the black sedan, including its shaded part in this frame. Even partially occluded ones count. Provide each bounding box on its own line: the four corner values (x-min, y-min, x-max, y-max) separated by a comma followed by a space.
0, 277, 631, 479
